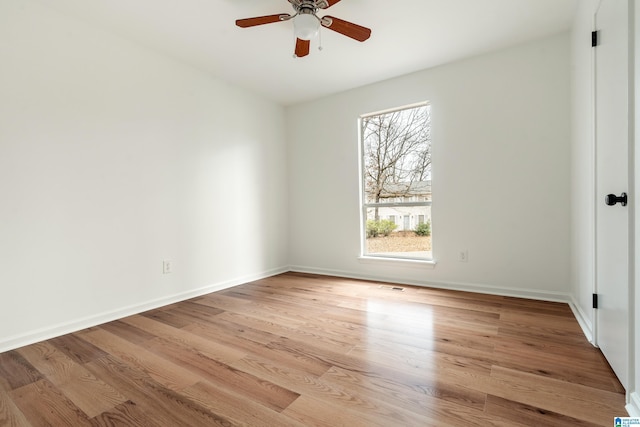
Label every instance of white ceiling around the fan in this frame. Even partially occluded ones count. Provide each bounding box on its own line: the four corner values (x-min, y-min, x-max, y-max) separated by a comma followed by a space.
39, 0, 578, 105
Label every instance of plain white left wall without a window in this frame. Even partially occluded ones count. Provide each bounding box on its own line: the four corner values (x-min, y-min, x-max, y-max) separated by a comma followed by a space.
0, 0, 287, 351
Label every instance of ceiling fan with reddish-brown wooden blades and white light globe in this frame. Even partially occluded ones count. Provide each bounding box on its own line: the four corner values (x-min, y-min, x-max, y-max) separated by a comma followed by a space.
236, 0, 371, 58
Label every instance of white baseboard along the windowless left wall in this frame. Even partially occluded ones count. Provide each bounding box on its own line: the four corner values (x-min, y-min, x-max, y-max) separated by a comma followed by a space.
0, 268, 288, 353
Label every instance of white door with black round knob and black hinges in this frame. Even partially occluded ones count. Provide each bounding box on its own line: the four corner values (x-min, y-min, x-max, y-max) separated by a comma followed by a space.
593, 0, 629, 388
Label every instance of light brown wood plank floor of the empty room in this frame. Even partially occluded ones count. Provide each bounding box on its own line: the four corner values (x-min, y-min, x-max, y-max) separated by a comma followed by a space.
0, 273, 626, 427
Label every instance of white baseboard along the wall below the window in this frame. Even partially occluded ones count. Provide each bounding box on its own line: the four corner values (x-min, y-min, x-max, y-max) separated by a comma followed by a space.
289, 265, 571, 305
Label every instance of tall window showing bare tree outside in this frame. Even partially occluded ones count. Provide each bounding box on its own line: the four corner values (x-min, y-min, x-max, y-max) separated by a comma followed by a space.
360, 103, 433, 260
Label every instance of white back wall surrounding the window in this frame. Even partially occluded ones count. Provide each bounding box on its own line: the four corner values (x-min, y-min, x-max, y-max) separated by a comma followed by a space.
286, 34, 571, 299
